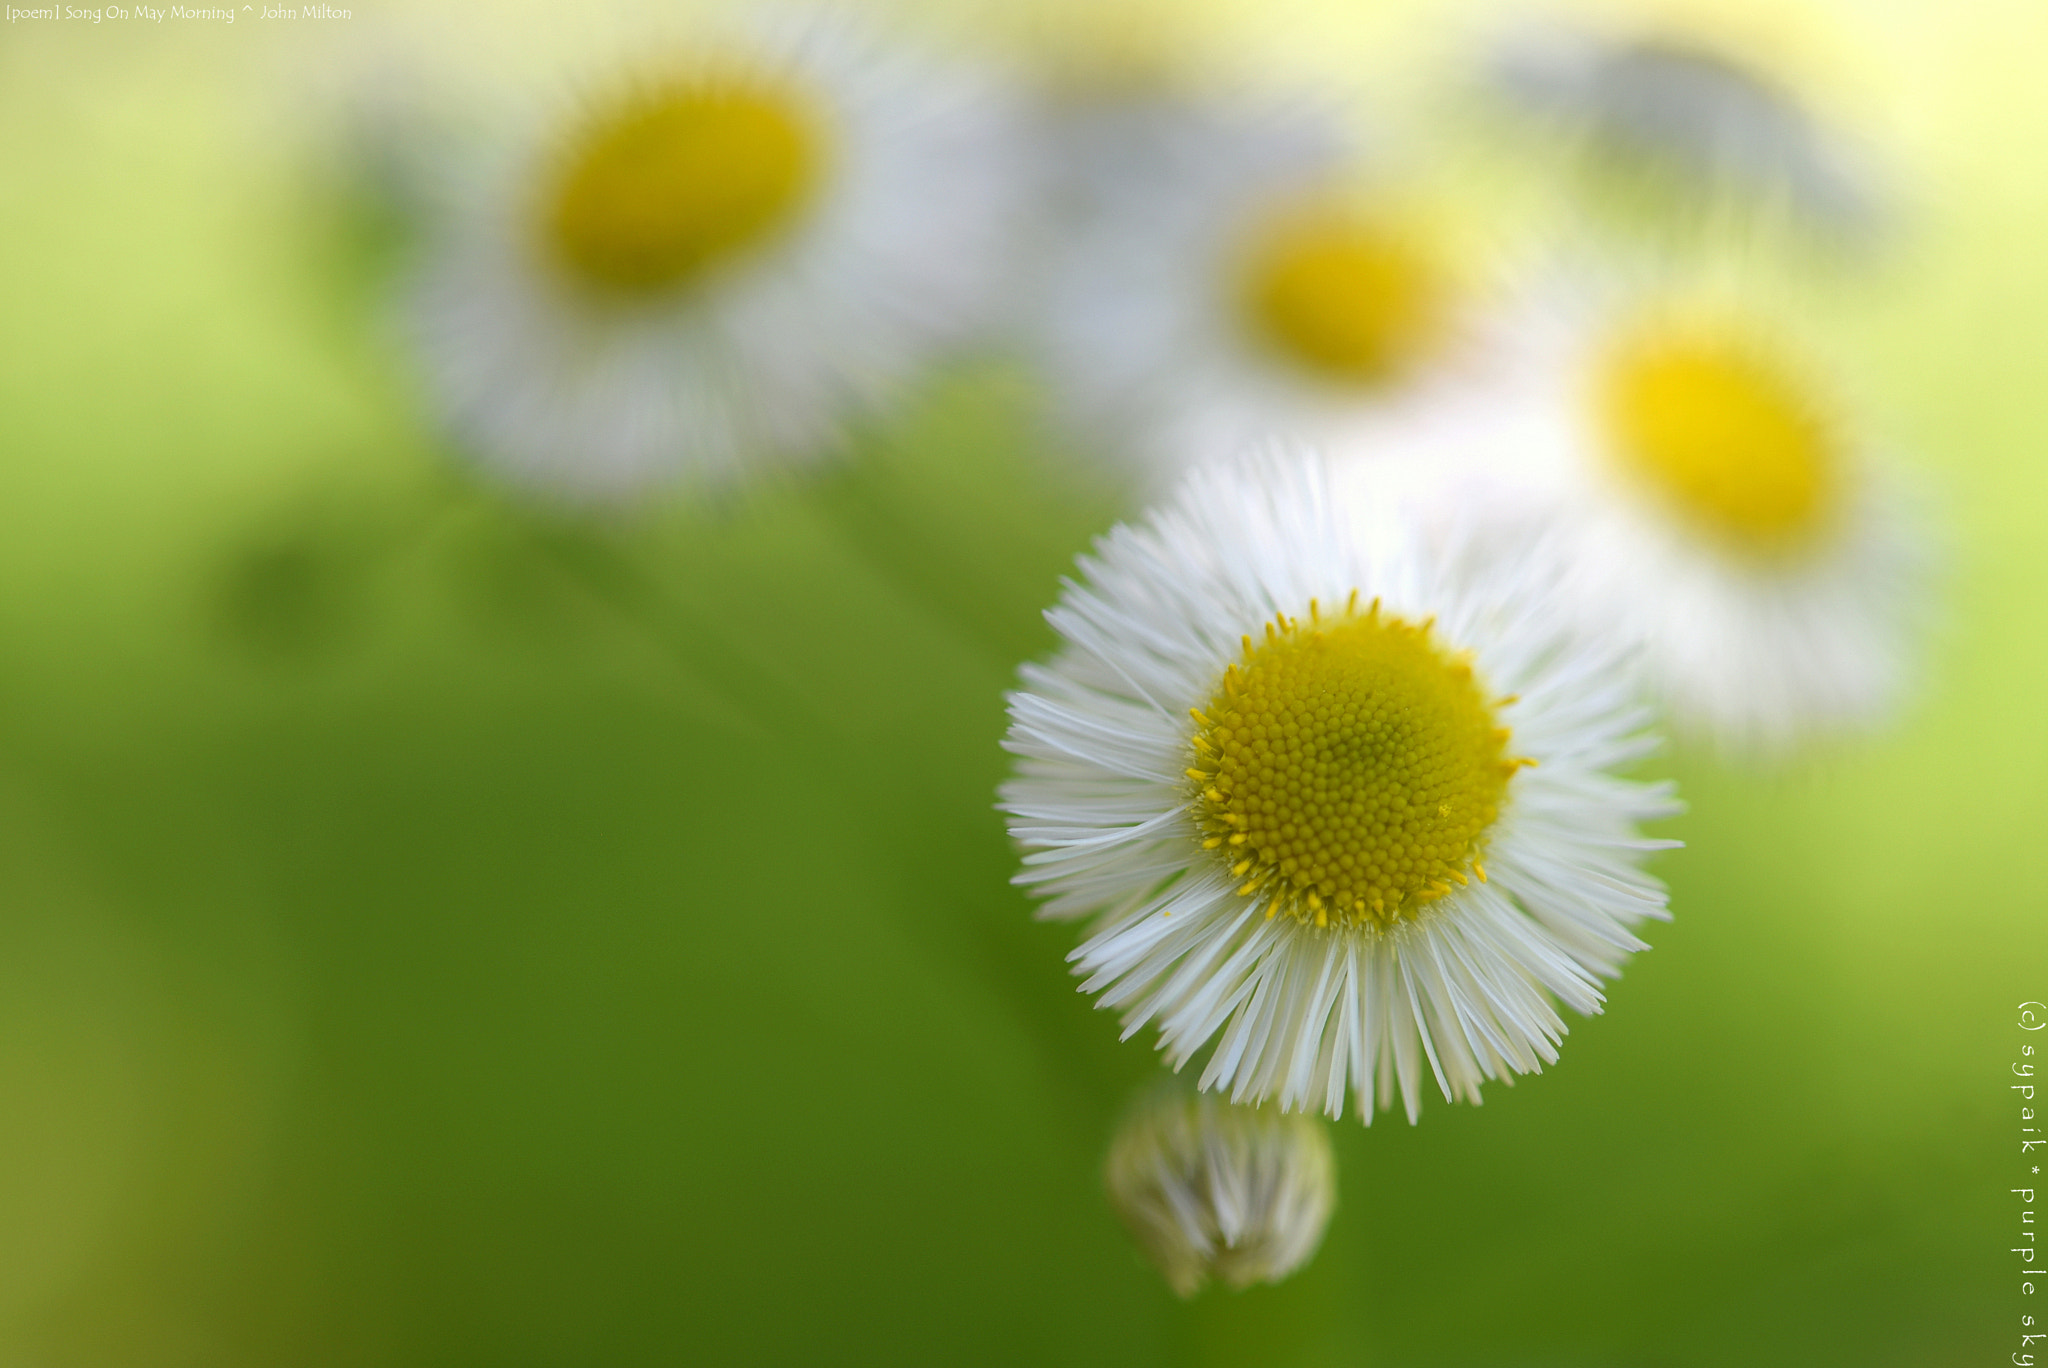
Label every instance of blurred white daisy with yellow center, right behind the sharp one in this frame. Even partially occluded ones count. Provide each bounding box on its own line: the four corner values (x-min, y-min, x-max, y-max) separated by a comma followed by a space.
1452, 311, 1927, 750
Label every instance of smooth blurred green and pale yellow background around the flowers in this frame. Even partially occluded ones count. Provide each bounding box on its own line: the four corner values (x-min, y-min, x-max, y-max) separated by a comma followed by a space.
0, 4, 2048, 1368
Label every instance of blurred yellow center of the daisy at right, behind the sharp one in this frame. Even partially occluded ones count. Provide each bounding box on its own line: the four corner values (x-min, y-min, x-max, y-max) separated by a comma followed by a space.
1599, 338, 1839, 553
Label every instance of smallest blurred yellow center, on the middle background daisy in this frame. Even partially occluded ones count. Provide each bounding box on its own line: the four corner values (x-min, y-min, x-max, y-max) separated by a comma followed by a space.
1243, 211, 1442, 387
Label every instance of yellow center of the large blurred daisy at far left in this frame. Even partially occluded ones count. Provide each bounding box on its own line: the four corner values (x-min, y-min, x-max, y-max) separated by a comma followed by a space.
549, 84, 819, 295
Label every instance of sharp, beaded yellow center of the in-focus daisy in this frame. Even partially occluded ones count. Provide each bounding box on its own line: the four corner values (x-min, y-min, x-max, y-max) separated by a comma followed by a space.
1188, 594, 1534, 928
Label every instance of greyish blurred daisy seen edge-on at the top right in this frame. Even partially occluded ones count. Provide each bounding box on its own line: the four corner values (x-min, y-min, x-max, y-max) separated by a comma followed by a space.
1491, 25, 1878, 229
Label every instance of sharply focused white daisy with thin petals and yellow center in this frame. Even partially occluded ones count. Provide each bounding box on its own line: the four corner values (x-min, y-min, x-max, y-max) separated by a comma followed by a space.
1001, 457, 1675, 1120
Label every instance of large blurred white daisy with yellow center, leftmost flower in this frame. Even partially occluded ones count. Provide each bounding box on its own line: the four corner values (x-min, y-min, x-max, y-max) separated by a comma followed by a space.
414, 18, 1022, 502
